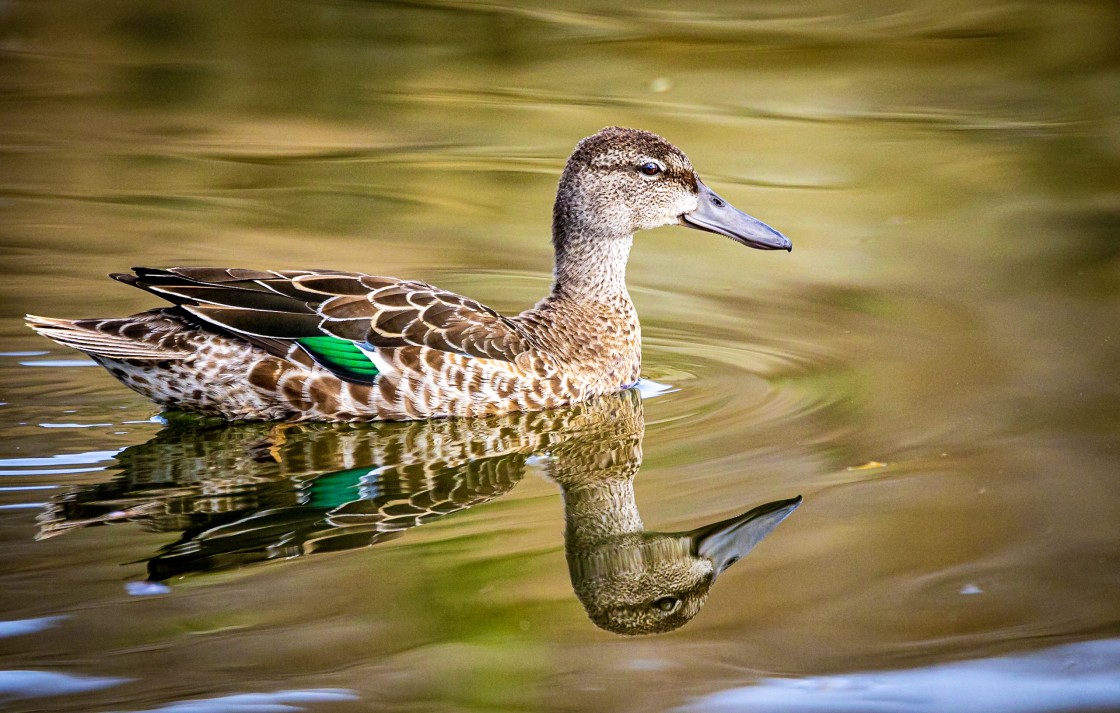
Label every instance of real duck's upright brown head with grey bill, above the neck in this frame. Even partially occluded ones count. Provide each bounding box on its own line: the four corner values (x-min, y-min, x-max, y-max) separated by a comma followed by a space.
553, 126, 792, 251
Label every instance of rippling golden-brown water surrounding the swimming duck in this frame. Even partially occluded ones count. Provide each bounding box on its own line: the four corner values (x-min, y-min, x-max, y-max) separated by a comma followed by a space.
0, 1, 1120, 711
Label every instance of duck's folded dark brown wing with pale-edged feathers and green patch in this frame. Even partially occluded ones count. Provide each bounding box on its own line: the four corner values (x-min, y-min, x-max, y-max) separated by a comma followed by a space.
111, 268, 532, 381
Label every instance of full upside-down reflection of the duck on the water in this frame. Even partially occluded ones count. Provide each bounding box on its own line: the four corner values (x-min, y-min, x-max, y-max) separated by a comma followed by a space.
39, 391, 801, 635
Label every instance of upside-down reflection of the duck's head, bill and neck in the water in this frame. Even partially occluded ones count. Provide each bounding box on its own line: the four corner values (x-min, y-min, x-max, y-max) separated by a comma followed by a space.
539, 400, 801, 635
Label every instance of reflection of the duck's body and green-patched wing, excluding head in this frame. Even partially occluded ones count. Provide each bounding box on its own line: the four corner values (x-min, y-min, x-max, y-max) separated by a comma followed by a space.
38, 391, 644, 580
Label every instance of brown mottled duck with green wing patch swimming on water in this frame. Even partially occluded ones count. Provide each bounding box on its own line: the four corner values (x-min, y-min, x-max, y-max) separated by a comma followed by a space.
26, 126, 792, 422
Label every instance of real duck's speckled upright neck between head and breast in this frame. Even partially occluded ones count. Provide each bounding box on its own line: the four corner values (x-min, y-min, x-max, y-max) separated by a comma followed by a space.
552, 180, 634, 302
